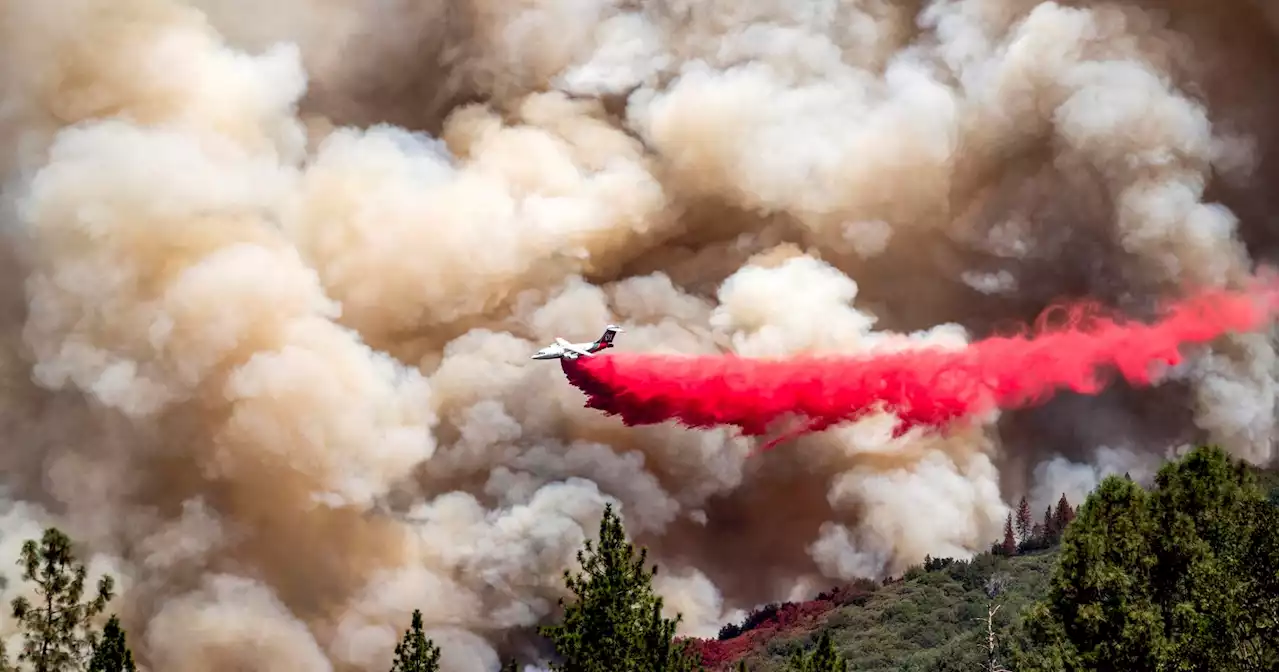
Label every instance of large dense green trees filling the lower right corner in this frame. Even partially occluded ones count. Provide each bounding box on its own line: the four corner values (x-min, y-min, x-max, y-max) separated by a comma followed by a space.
1019, 447, 1280, 672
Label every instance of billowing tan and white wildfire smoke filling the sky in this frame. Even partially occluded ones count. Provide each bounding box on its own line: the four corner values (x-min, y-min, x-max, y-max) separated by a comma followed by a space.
0, 0, 1280, 672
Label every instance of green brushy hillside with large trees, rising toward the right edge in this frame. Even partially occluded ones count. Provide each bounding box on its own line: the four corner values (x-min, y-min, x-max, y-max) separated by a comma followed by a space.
704, 447, 1280, 672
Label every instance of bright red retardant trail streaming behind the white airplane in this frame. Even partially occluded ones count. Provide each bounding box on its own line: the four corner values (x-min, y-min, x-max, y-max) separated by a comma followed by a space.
561, 280, 1280, 448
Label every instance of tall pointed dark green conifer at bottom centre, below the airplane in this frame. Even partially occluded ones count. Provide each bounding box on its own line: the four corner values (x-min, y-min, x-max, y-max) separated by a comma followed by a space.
540, 504, 699, 672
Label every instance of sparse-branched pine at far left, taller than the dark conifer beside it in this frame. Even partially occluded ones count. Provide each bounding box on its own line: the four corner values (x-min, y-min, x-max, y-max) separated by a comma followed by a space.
0, 527, 115, 672
